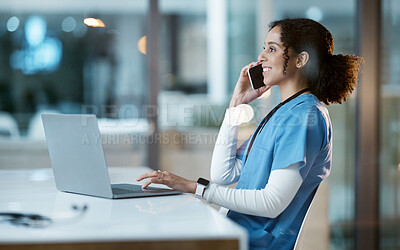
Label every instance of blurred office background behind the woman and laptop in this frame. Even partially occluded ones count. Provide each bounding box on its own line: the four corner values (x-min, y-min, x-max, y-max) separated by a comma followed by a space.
0, 0, 400, 249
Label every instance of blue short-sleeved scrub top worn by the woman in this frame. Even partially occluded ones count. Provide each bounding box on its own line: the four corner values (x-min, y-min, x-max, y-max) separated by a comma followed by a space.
227, 94, 332, 250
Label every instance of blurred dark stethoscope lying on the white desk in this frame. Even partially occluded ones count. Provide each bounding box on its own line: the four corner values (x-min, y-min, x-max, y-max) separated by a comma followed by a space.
0, 204, 88, 228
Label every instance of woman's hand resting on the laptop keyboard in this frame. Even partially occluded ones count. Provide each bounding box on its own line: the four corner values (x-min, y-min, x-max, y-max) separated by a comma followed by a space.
136, 170, 197, 194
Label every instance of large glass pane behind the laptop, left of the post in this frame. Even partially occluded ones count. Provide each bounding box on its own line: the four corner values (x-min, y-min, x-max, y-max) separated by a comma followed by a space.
0, 0, 148, 168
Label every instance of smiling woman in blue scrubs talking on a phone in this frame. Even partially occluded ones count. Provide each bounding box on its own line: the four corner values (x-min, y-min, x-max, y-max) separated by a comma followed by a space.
137, 19, 361, 249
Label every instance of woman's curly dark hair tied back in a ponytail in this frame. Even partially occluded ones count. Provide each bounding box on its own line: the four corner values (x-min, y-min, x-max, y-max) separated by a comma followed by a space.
269, 18, 363, 105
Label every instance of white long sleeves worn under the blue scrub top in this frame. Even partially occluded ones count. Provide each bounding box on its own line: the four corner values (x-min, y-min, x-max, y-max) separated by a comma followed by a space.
203, 109, 303, 218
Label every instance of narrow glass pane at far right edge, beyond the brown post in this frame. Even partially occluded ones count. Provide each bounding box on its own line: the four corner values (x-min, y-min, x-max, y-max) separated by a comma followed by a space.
379, 0, 400, 249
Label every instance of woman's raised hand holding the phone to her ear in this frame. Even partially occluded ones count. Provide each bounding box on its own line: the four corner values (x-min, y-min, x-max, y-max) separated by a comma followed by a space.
229, 62, 270, 108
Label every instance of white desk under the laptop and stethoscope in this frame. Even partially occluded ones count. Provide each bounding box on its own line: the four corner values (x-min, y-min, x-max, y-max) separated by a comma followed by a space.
0, 167, 247, 250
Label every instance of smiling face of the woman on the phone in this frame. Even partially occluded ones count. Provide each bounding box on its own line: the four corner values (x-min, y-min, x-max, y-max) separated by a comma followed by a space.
258, 26, 295, 86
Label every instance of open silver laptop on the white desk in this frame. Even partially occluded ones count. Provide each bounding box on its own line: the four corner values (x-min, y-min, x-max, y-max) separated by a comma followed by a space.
42, 114, 182, 199
